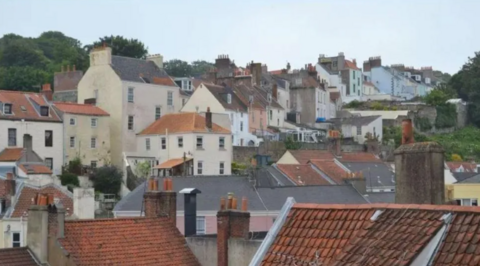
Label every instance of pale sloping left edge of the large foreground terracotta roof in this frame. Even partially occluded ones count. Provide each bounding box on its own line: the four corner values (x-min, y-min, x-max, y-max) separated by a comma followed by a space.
250, 197, 296, 265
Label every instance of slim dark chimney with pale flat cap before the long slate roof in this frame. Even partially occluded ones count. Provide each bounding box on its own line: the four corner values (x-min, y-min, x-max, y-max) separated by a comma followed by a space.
179, 188, 202, 237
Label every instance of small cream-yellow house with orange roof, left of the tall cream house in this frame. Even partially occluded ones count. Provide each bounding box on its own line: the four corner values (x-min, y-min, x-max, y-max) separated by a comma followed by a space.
54, 102, 111, 168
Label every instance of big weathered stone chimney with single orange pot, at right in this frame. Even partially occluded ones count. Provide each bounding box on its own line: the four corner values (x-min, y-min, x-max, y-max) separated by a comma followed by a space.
394, 119, 445, 204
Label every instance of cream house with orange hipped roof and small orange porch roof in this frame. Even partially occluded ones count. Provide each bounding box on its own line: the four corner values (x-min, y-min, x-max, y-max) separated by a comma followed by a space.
137, 110, 232, 176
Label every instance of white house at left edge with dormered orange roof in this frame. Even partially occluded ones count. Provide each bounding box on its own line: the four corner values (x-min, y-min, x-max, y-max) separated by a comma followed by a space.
0, 88, 64, 174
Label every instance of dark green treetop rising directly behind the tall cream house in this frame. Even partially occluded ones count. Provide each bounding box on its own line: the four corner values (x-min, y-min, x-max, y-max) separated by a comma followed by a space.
85, 35, 148, 59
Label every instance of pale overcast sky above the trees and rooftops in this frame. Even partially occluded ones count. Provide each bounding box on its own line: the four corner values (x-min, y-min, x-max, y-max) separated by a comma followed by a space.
0, 0, 480, 74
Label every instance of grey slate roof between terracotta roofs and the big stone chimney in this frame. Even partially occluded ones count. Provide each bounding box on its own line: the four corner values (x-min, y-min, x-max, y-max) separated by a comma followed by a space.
342, 162, 395, 188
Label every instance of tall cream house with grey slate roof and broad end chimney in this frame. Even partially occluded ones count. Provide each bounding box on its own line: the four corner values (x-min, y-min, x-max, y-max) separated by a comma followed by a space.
78, 47, 182, 169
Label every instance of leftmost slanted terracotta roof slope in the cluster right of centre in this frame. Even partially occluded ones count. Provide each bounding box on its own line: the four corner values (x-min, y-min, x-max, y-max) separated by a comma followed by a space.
277, 164, 332, 185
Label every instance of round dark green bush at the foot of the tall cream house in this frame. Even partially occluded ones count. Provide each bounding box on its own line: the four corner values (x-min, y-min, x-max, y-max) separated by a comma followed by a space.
90, 165, 123, 195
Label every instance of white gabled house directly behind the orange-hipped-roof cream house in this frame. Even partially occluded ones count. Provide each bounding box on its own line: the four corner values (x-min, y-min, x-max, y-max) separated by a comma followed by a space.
181, 83, 259, 146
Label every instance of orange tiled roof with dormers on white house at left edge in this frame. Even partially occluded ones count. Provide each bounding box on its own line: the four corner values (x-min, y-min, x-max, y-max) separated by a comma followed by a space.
0, 90, 61, 122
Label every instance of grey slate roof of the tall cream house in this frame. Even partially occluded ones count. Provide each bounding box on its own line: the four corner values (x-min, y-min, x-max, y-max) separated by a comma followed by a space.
112, 56, 172, 83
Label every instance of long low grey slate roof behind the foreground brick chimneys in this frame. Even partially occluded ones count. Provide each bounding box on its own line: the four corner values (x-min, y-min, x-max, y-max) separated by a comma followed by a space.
114, 176, 367, 211
